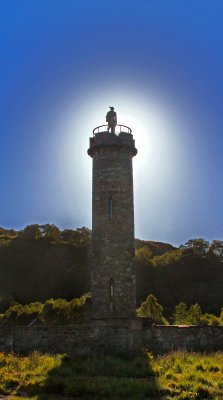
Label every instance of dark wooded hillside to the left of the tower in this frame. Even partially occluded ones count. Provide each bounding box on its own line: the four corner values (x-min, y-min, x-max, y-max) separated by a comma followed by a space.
0, 224, 91, 304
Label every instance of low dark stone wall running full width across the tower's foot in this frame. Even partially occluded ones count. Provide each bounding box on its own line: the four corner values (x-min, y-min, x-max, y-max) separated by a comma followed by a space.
0, 324, 223, 354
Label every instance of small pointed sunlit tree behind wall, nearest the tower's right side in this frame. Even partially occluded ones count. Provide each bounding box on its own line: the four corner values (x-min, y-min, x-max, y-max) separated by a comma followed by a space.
136, 294, 167, 324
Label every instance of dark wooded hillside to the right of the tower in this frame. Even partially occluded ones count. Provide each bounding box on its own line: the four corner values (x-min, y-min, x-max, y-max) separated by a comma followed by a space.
136, 241, 223, 318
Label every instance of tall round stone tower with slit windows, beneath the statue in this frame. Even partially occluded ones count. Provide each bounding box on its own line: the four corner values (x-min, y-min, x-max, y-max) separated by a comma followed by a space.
88, 110, 137, 320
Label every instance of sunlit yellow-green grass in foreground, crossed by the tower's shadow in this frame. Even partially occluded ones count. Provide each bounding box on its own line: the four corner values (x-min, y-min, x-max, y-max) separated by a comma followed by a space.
0, 351, 223, 400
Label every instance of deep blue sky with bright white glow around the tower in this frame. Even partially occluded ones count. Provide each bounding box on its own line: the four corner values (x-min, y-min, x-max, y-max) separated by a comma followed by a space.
0, 0, 223, 244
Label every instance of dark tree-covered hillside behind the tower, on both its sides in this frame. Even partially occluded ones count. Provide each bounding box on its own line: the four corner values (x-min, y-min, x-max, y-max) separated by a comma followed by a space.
0, 224, 223, 318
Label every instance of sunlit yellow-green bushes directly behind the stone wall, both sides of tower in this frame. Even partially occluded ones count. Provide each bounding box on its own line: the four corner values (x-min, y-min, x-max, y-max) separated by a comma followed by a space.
0, 293, 223, 326
